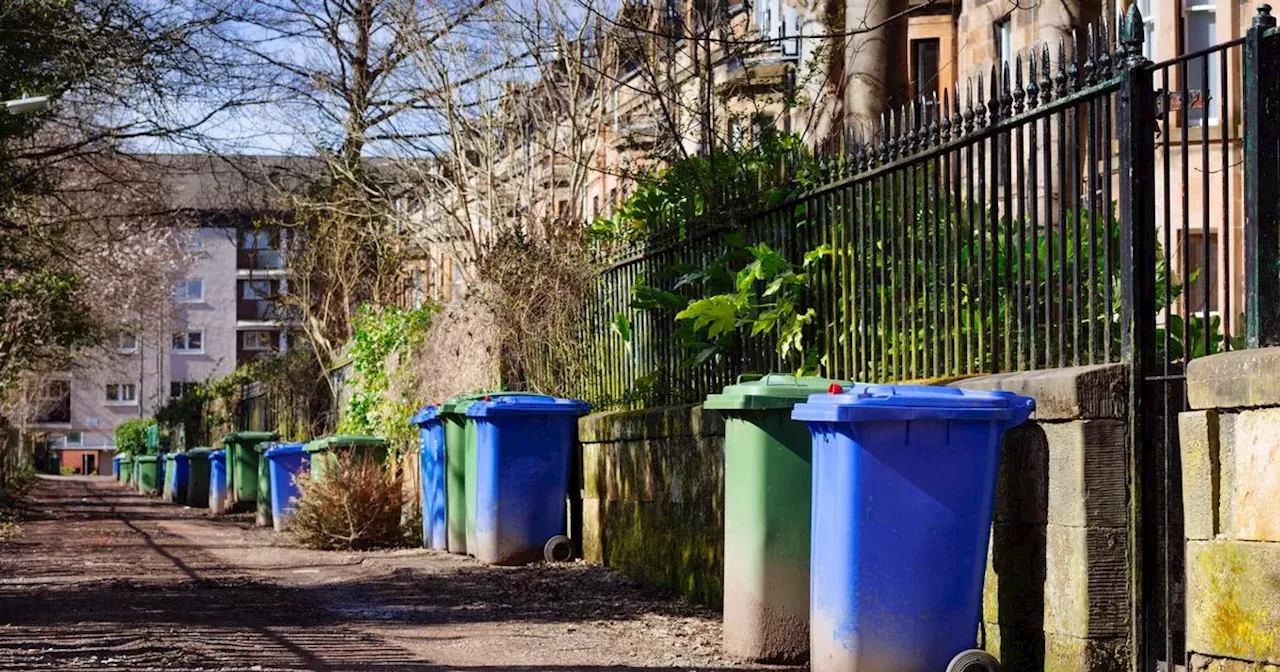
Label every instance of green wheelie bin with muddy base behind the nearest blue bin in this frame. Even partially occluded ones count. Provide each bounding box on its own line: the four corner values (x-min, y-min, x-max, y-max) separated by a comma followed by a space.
704, 374, 850, 663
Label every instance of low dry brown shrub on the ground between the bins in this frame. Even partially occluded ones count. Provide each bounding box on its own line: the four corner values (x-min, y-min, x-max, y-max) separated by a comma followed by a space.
291, 451, 404, 550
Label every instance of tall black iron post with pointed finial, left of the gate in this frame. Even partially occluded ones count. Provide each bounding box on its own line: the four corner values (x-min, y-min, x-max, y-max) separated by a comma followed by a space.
1116, 3, 1156, 672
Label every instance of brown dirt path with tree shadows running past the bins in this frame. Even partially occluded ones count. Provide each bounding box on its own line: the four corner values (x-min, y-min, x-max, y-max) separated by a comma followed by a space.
0, 477, 798, 672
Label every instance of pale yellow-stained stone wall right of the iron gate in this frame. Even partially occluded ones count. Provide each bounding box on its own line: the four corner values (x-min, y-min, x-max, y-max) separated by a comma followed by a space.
1179, 348, 1280, 672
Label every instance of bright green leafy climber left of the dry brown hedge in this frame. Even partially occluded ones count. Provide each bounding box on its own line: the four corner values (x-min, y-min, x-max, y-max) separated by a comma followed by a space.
338, 305, 436, 442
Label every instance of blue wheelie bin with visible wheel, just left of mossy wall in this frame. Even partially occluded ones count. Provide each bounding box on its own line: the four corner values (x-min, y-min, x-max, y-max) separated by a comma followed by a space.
467, 394, 589, 564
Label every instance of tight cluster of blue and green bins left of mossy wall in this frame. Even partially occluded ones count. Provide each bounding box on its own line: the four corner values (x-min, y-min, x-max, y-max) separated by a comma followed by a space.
411, 392, 589, 564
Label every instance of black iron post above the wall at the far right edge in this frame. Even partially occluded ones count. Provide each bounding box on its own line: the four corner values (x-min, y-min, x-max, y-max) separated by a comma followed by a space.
1244, 5, 1280, 348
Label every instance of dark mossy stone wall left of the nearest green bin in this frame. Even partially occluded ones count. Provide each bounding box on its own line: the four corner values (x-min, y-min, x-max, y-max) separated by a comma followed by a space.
579, 406, 724, 607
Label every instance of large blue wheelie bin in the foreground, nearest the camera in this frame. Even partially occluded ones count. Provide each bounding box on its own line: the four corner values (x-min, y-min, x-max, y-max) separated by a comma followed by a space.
792, 385, 1036, 672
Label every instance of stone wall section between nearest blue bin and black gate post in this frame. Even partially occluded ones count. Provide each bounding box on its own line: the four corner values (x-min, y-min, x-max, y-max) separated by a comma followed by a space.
956, 365, 1130, 672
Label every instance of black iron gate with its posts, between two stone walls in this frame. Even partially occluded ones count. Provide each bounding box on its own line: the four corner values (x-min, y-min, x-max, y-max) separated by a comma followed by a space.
1116, 5, 1280, 672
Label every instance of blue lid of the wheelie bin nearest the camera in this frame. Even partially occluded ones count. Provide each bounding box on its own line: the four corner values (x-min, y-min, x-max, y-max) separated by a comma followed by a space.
791, 385, 1036, 425
